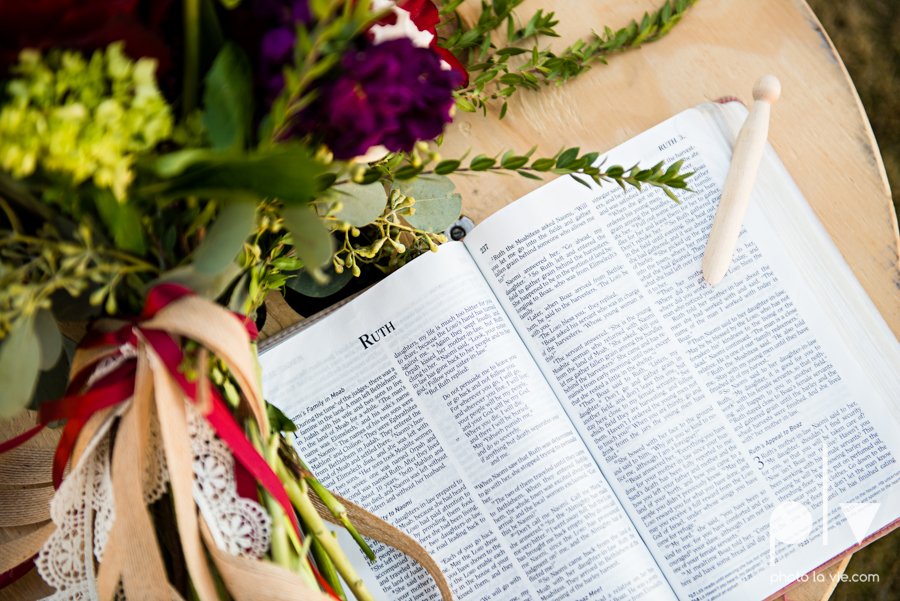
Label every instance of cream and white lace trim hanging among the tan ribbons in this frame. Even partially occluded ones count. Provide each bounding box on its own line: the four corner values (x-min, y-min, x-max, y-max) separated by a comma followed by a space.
35, 378, 272, 601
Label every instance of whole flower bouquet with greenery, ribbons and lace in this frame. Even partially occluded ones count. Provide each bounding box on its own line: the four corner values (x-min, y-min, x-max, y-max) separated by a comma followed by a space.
0, 0, 690, 601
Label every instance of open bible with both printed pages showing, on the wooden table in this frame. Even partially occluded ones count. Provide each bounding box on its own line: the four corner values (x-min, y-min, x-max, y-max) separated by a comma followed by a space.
260, 103, 900, 601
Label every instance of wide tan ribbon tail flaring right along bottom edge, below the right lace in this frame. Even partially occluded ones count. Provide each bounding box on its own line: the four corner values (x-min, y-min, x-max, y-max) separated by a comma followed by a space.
200, 517, 334, 601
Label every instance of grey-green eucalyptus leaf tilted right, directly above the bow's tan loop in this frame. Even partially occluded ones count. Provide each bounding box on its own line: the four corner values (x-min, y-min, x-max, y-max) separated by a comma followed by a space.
194, 202, 256, 275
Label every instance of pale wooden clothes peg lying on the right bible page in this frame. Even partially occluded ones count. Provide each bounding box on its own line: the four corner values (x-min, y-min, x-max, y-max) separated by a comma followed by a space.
703, 75, 781, 284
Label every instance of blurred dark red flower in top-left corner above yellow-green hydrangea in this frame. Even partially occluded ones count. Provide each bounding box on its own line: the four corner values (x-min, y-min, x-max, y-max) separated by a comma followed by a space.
0, 0, 171, 75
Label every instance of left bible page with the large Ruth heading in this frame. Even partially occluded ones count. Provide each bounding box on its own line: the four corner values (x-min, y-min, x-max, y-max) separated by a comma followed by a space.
260, 243, 675, 601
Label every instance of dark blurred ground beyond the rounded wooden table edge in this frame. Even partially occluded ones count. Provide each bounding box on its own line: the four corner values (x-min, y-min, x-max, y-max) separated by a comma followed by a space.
807, 0, 900, 601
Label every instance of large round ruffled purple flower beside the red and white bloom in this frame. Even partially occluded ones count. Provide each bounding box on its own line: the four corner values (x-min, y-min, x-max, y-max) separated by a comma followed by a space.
294, 38, 460, 160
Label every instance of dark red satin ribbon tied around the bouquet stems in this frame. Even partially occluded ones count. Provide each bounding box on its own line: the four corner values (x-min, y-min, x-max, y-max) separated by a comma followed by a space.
0, 284, 337, 598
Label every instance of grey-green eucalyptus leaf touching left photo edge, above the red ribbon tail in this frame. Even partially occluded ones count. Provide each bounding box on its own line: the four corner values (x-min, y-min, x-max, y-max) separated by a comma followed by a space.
0, 316, 40, 419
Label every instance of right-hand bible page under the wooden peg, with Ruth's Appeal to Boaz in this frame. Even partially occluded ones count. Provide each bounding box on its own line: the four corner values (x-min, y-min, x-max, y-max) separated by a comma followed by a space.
465, 107, 900, 600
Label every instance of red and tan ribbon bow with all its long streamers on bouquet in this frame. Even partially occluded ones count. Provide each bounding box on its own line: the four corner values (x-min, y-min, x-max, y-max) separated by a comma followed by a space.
0, 284, 453, 601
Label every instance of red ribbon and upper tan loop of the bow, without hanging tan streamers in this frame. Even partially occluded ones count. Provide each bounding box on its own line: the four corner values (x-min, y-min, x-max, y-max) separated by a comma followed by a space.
0, 284, 282, 502
